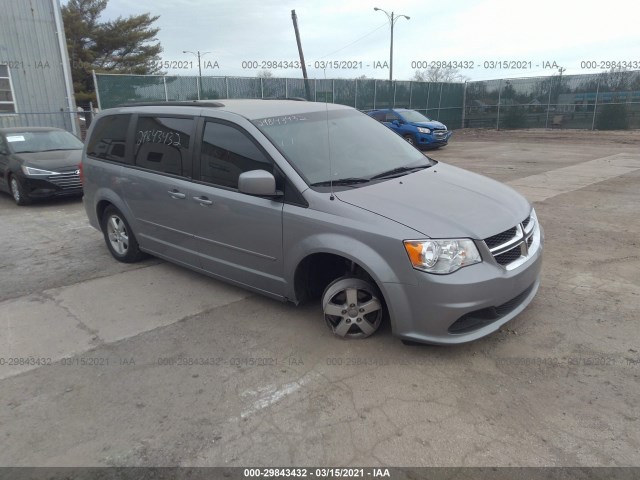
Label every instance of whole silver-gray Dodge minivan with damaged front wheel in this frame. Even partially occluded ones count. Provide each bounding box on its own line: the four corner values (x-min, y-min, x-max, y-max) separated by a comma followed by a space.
81, 100, 543, 344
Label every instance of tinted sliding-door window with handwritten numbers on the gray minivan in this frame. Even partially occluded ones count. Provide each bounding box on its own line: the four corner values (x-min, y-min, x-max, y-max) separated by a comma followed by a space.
134, 116, 195, 175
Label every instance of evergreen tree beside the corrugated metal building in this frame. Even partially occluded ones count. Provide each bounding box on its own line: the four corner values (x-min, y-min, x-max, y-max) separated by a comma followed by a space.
62, 0, 162, 103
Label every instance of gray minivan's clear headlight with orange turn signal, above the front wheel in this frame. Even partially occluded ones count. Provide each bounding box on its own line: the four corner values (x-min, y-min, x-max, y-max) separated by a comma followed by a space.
404, 238, 482, 274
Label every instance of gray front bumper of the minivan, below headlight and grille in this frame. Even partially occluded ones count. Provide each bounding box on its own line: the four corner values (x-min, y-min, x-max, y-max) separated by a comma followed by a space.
383, 223, 544, 345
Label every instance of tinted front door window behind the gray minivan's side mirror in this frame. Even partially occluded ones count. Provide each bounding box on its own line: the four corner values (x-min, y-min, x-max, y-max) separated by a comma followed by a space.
200, 122, 272, 188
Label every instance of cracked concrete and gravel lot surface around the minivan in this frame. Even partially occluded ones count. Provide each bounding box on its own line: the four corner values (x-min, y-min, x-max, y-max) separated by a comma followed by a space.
0, 130, 640, 466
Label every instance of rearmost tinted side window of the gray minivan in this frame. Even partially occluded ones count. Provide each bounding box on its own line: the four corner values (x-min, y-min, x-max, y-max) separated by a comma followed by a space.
87, 115, 131, 163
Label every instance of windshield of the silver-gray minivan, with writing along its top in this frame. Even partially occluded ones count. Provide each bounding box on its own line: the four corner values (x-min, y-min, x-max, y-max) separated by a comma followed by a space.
253, 110, 433, 187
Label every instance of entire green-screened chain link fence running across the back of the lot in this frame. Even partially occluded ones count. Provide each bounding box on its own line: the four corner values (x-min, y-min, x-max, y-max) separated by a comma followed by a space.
89, 71, 640, 130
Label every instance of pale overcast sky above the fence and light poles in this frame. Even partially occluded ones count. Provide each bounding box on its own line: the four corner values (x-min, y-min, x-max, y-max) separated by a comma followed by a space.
102, 0, 640, 80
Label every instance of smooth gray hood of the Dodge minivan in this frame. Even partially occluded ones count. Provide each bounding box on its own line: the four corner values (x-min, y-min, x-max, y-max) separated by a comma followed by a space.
335, 163, 531, 240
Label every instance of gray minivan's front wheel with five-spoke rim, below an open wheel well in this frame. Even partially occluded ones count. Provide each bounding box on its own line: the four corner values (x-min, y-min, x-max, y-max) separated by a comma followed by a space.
322, 277, 384, 338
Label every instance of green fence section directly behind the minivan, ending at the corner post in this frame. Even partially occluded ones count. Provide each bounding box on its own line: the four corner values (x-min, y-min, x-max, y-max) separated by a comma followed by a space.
96, 74, 465, 128
